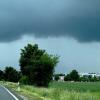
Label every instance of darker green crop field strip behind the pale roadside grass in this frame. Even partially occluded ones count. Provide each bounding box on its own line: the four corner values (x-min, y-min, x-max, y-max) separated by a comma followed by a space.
50, 82, 100, 92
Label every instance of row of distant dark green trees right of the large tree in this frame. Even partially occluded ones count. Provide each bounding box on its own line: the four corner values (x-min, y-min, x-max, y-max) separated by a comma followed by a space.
54, 70, 100, 82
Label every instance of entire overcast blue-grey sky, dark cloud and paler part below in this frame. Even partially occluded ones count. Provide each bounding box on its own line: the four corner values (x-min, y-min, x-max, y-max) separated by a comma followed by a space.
0, 0, 100, 73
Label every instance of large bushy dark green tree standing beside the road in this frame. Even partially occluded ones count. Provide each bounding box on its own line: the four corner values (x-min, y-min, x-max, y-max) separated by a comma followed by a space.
19, 44, 58, 86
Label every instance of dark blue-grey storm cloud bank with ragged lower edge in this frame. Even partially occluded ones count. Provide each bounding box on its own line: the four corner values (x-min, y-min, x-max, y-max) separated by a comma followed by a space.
0, 0, 100, 42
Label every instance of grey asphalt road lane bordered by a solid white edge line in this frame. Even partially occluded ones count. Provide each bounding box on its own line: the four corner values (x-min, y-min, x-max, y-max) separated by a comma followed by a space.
0, 86, 19, 100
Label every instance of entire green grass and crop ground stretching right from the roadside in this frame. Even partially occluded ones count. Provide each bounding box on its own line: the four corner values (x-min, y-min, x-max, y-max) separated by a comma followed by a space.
1, 82, 100, 100
